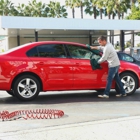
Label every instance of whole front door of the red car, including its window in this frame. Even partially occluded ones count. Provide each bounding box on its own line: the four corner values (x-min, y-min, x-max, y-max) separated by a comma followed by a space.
67, 45, 108, 89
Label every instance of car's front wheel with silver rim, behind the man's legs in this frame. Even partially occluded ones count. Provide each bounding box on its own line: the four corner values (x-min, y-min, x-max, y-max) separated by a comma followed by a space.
115, 73, 138, 95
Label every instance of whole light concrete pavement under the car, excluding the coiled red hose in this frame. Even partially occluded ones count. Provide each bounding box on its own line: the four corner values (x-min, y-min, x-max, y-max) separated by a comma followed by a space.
0, 91, 140, 140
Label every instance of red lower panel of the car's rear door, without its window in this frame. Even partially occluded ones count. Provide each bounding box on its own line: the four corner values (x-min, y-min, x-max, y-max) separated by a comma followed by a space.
30, 57, 73, 90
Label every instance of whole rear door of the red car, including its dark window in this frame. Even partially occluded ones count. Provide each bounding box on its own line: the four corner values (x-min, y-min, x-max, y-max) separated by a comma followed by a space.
27, 44, 73, 90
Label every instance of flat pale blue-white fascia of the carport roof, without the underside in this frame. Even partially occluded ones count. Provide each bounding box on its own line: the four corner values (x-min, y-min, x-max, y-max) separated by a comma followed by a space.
0, 16, 140, 30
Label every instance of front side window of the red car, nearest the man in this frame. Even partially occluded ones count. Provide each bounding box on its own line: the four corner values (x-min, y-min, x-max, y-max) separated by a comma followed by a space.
67, 45, 97, 59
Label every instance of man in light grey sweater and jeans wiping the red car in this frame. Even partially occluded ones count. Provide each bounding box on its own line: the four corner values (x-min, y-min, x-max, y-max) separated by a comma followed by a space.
90, 36, 127, 98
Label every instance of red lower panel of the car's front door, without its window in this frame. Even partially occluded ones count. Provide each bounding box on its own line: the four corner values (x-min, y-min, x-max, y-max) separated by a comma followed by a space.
70, 59, 108, 89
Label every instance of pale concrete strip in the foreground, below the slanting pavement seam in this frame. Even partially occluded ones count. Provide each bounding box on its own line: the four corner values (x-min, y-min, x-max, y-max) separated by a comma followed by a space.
0, 116, 140, 140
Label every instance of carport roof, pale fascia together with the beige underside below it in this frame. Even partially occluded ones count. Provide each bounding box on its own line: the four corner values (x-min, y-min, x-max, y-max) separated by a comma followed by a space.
0, 16, 140, 38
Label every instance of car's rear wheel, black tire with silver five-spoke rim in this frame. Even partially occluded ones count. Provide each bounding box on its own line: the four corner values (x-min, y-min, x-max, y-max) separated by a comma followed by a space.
13, 75, 40, 101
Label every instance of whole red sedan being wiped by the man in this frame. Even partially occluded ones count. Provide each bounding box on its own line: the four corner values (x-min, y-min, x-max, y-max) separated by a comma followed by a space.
0, 41, 140, 101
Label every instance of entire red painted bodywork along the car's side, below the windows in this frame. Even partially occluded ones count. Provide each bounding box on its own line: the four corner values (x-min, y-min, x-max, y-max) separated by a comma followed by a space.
0, 42, 140, 94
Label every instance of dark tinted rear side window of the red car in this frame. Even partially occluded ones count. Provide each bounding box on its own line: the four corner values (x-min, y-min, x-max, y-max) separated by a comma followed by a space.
27, 44, 66, 58
